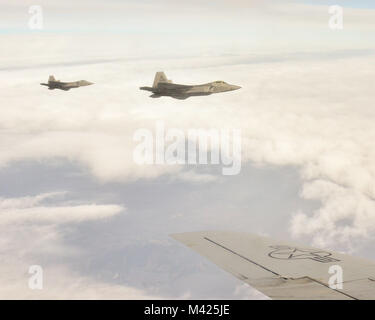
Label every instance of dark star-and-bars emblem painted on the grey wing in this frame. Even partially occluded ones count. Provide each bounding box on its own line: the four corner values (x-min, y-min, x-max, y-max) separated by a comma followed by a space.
268, 246, 340, 263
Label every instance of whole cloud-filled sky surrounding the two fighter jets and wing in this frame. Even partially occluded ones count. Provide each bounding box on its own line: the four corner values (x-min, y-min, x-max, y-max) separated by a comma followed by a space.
0, 0, 375, 299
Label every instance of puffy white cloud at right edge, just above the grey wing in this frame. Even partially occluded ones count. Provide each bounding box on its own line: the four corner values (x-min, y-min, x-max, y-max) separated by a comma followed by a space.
291, 180, 375, 250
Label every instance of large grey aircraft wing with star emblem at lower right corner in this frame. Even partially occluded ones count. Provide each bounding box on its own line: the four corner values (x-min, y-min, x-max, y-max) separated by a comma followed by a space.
171, 231, 375, 300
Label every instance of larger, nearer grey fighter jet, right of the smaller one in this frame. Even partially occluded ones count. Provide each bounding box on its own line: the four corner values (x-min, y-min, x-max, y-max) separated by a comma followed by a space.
140, 72, 241, 100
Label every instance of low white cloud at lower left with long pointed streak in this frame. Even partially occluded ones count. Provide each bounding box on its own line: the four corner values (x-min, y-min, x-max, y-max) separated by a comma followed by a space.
0, 192, 167, 299
